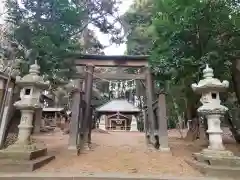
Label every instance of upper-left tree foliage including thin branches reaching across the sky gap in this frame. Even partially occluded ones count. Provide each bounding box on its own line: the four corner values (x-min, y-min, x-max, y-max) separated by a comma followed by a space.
6, 0, 122, 79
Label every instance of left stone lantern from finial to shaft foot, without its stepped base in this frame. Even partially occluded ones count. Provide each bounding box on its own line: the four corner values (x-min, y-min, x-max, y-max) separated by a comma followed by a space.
13, 61, 49, 150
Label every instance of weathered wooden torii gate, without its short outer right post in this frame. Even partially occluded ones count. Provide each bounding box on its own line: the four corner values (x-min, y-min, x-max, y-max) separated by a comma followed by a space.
69, 55, 169, 152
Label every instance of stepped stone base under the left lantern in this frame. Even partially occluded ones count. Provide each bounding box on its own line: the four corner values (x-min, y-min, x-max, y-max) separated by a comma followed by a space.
0, 143, 55, 172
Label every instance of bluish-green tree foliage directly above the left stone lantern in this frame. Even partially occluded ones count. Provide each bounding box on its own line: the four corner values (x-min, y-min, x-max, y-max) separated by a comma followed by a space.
7, 0, 84, 77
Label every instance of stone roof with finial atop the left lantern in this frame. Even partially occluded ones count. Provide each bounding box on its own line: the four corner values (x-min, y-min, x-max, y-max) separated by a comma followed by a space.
16, 61, 49, 89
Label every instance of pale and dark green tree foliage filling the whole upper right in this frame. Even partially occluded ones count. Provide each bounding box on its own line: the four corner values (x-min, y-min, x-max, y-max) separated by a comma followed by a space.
125, 0, 240, 126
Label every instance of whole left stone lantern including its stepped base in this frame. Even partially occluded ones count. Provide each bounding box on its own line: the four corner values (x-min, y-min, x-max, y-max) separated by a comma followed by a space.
0, 62, 54, 172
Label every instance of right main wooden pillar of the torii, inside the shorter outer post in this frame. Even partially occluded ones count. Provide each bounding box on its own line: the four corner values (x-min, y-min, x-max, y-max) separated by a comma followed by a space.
143, 67, 157, 145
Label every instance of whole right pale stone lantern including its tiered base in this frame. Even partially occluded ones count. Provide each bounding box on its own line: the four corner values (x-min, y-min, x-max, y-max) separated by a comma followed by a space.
186, 65, 240, 178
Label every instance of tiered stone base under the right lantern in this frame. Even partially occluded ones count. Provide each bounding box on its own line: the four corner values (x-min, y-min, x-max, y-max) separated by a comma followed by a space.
186, 149, 240, 178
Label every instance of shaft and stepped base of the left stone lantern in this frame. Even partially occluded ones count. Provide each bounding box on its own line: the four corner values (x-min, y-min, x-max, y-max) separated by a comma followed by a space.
0, 106, 55, 172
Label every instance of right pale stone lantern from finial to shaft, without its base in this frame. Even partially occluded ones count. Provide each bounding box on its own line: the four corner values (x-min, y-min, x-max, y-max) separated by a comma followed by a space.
192, 65, 229, 150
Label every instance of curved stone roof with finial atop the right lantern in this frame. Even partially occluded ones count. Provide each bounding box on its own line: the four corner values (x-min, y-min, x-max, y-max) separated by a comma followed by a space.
192, 64, 229, 94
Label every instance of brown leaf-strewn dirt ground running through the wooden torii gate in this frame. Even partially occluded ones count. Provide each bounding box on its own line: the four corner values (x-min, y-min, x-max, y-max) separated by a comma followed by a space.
33, 130, 240, 176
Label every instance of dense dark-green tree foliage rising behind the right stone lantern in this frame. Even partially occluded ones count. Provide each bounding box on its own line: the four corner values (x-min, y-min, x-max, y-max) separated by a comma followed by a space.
151, 0, 240, 122
